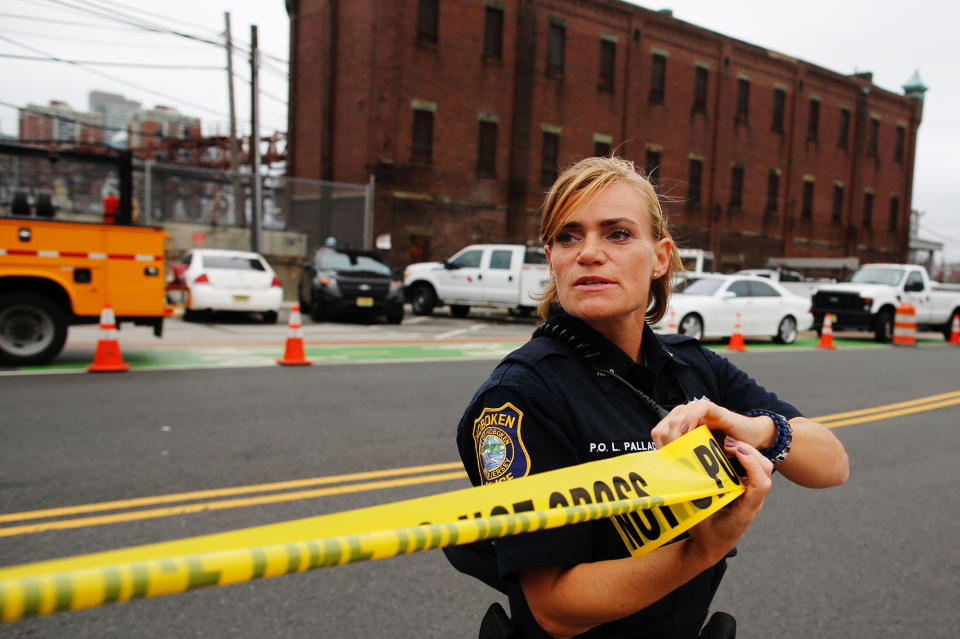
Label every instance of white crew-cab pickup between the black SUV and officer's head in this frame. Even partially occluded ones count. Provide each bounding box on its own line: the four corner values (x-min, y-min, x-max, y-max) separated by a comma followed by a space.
403, 244, 550, 317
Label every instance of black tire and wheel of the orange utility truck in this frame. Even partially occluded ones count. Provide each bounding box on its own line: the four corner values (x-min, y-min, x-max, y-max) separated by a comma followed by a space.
0, 293, 67, 366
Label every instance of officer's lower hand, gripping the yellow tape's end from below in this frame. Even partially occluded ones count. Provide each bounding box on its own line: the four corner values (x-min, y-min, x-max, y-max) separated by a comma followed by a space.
690, 436, 773, 563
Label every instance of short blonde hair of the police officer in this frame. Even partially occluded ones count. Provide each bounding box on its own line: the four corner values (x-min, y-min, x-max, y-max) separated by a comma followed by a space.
537, 157, 683, 324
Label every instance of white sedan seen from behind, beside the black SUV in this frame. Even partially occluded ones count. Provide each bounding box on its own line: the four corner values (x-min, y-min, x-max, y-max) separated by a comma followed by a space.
173, 249, 283, 324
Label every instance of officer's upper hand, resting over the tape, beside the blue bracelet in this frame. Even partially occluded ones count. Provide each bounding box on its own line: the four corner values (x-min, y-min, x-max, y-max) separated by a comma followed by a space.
651, 399, 777, 449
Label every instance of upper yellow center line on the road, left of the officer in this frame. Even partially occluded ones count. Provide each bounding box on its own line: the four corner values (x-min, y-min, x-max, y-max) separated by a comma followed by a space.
0, 462, 463, 524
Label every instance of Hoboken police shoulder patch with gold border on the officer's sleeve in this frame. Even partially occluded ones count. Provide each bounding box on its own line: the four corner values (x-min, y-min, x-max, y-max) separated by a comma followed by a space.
473, 402, 530, 484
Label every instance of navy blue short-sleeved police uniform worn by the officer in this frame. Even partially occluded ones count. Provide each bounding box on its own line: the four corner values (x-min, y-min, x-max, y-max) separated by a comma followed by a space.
457, 311, 800, 638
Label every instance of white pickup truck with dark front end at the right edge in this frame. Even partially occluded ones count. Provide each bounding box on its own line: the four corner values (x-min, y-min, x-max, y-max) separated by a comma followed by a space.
811, 264, 960, 342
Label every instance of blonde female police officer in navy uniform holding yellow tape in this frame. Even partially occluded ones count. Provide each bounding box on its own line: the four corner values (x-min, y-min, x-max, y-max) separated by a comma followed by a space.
457, 158, 848, 638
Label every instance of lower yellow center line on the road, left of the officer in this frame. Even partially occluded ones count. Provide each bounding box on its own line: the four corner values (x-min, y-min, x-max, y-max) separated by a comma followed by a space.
0, 471, 467, 537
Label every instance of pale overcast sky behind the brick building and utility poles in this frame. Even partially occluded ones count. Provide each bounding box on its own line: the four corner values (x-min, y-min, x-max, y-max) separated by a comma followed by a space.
0, 0, 960, 261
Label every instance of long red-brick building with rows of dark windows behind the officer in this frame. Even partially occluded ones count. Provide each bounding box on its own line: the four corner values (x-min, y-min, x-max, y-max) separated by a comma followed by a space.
287, 0, 926, 270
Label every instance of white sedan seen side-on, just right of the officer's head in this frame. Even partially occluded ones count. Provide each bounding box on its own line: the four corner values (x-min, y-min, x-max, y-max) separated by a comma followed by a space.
653, 274, 813, 344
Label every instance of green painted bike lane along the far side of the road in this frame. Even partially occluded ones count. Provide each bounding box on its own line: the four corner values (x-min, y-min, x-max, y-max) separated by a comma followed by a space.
17, 336, 944, 372
